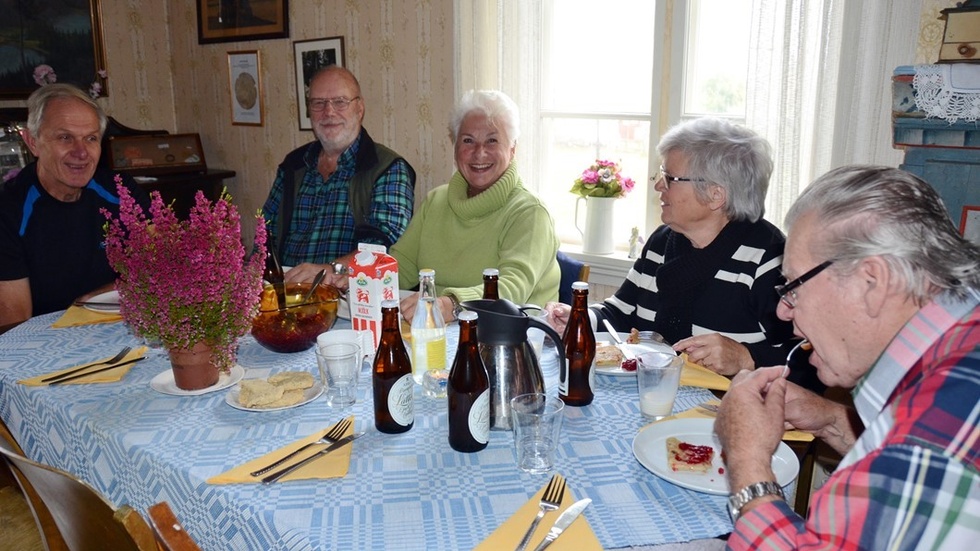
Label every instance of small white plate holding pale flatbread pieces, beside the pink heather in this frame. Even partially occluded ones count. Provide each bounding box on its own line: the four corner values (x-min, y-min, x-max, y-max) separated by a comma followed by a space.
225, 371, 323, 412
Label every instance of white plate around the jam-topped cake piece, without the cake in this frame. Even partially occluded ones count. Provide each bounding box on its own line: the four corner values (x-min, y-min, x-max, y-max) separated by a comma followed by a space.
633, 419, 800, 495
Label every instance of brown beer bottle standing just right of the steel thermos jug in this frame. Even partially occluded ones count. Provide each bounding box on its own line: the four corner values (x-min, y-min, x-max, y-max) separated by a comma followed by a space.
558, 281, 595, 406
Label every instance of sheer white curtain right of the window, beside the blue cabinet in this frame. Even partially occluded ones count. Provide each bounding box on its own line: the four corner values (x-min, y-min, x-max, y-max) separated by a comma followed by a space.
746, 0, 921, 225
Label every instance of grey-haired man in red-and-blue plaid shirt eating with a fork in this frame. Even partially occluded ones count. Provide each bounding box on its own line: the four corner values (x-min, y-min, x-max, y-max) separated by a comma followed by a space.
715, 166, 980, 549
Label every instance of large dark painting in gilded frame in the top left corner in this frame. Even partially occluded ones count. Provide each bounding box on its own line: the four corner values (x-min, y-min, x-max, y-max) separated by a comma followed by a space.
0, 0, 109, 100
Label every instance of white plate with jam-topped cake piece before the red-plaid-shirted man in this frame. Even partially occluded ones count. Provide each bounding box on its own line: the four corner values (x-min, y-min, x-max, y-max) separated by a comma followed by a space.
633, 418, 800, 495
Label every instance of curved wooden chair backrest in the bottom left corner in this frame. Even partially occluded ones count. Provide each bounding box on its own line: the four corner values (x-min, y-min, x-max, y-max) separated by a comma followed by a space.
0, 438, 198, 551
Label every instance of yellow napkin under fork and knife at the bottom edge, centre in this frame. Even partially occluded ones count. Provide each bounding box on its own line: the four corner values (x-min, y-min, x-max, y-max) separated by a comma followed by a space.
475, 474, 602, 551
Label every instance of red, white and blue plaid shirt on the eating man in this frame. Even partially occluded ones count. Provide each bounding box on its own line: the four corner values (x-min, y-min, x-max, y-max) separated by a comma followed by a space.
728, 289, 980, 549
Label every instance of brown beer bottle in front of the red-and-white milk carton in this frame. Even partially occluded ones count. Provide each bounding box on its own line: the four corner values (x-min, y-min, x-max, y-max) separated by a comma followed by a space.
371, 300, 415, 434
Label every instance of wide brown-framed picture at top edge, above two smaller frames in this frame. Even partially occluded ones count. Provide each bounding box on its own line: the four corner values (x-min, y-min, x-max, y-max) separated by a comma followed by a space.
197, 0, 289, 44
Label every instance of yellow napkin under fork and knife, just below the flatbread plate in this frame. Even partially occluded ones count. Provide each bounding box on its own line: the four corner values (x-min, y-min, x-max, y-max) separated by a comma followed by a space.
208, 415, 357, 484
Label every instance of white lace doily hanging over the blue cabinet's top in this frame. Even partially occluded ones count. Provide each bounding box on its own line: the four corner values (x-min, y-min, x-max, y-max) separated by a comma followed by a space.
912, 63, 980, 124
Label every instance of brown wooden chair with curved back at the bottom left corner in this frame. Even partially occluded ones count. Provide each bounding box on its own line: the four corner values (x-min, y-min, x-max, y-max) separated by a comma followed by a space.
0, 436, 200, 551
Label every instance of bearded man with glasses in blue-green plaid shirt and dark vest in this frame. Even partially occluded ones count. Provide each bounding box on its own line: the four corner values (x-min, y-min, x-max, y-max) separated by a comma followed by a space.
262, 65, 415, 289
